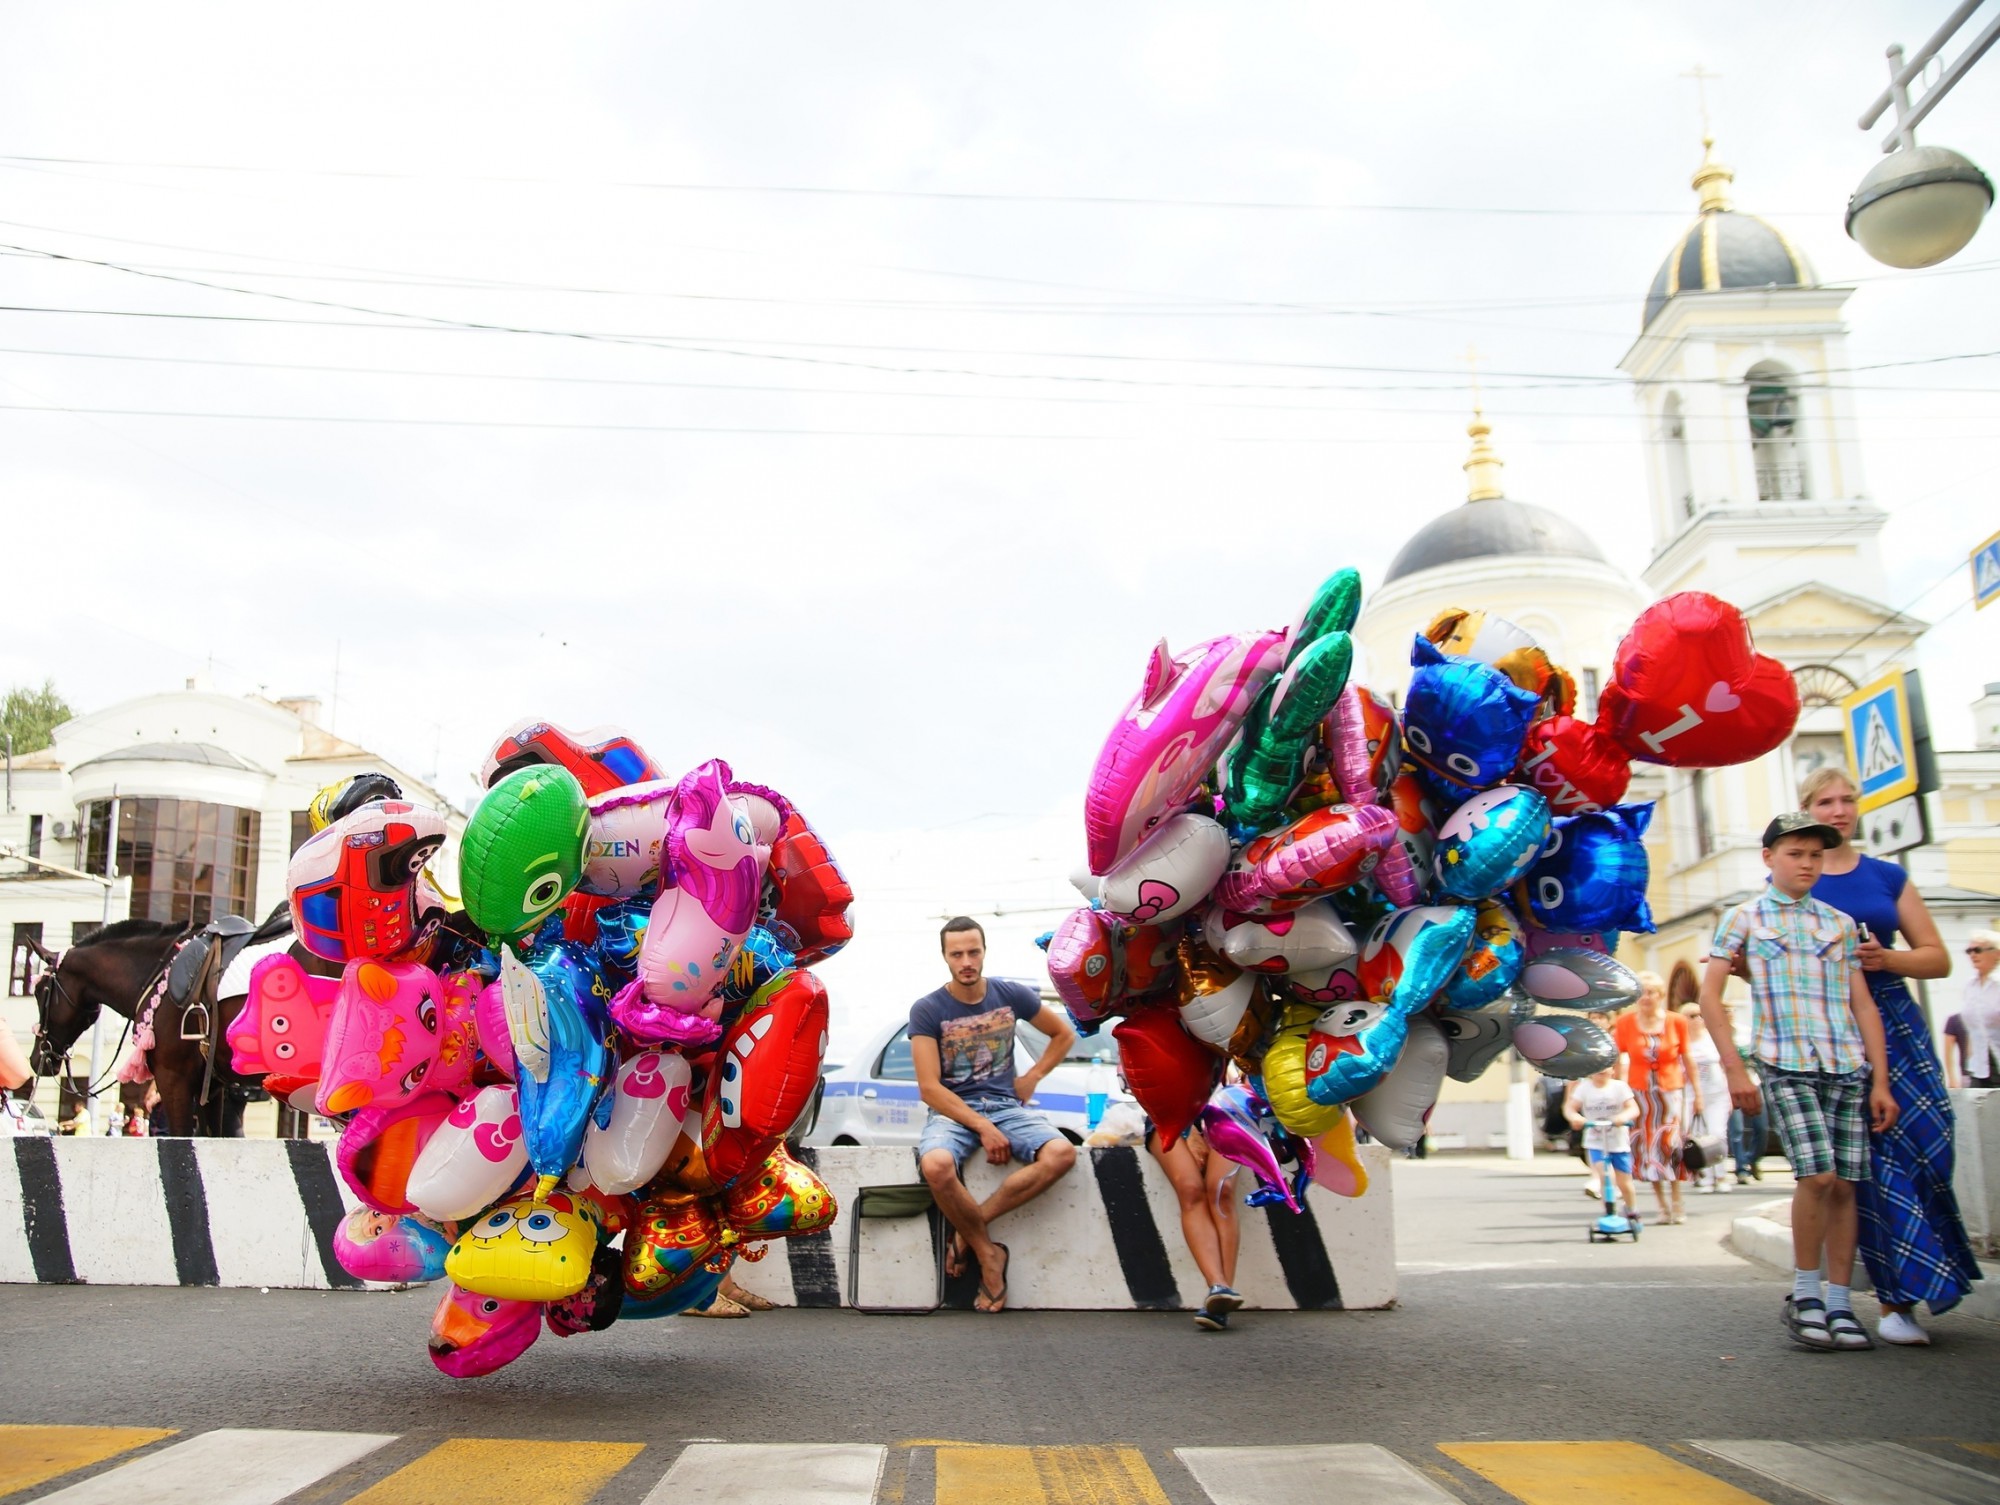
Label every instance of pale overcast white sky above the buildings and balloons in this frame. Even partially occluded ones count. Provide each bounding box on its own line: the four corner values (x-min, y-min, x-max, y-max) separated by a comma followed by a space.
0, 0, 2000, 1049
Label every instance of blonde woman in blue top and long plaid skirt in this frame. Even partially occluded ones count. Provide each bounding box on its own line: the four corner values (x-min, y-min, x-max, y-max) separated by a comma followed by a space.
1798, 769, 1980, 1345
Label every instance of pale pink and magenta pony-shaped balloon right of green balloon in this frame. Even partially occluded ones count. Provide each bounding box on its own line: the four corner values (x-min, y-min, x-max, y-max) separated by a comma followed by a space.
612, 761, 770, 1045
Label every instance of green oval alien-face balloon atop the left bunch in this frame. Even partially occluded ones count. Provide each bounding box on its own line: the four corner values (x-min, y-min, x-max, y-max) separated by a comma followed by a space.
458, 765, 590, 941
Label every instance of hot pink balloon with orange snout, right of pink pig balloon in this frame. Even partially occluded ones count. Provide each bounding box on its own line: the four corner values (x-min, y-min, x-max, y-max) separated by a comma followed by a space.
314, 961, 484, 1117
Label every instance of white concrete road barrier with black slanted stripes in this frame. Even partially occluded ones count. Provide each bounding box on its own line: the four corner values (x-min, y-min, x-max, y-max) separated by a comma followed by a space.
0, 1137, 1396, 1311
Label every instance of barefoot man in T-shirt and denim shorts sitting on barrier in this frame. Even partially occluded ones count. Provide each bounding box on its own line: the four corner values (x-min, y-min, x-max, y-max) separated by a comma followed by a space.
910, 915, 1076, 1311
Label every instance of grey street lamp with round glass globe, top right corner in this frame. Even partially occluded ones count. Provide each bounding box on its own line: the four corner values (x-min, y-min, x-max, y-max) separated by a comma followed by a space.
1848, 0, 2000, 268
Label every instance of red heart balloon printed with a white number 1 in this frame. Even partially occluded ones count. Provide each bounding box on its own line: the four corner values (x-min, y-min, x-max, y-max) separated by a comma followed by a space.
1598, 590, 1798, 769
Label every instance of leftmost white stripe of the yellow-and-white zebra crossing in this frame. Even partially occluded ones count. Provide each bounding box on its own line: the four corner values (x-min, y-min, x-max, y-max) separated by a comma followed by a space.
29, 1427, 396, 1505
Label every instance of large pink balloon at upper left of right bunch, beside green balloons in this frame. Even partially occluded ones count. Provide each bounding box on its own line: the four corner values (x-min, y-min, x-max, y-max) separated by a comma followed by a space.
1084, 632, 1286, 875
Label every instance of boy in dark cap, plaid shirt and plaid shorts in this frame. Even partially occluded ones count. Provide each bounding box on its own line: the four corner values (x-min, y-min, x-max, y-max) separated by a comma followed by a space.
1702, 811, 1896, 1349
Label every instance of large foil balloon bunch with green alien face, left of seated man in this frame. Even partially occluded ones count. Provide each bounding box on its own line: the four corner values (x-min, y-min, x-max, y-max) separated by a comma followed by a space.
228, 720, 854, 1377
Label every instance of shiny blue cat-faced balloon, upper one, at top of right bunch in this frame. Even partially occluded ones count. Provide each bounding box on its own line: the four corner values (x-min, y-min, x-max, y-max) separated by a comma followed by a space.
1402, 636, 1540, 805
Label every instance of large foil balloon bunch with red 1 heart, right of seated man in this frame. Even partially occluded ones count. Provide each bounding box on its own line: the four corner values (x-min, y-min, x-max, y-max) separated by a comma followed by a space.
1044, 570, 1798, 1209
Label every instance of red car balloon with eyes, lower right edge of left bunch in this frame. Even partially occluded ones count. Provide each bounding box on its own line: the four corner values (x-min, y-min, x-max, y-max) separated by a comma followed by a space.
702, 967, 826, 1187
